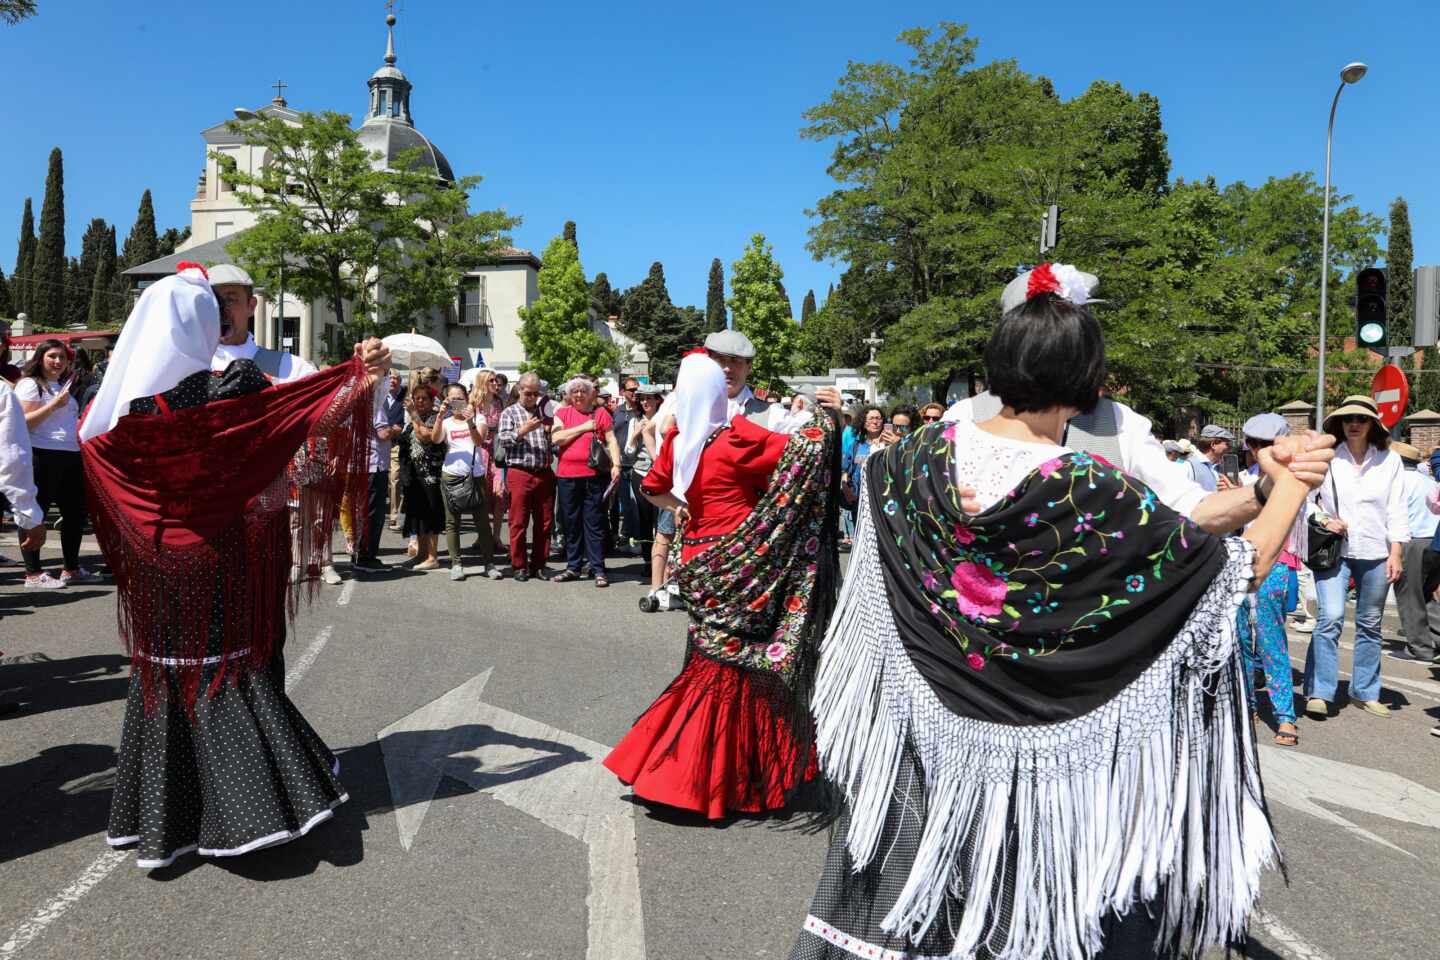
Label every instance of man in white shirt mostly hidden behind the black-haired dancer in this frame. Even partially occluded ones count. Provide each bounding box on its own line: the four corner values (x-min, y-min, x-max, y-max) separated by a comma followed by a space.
945, 263, 1329, 534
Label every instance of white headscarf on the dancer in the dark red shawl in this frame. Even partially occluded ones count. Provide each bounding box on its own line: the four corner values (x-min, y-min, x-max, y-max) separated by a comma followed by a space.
81, 268, 220, 443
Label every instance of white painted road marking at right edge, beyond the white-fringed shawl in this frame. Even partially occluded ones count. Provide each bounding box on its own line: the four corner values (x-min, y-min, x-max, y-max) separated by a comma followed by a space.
1260, 747, 1440, 858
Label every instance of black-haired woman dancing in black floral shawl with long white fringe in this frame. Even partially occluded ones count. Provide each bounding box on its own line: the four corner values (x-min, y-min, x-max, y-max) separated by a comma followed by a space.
791, 263, 1330, 960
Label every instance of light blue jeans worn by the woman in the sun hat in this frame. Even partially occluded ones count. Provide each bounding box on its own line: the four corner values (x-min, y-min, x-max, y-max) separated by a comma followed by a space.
1302, 557, 1390, 702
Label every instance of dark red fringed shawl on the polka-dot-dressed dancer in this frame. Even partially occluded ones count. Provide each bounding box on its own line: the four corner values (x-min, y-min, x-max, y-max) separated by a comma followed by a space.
81, 360, 374, 711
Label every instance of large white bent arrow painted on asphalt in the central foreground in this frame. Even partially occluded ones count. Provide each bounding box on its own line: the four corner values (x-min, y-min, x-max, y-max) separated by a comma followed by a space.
380, 671, 645, 960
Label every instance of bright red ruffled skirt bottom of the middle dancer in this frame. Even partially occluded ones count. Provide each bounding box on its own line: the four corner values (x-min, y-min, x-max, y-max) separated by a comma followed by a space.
605, 652, 816, 820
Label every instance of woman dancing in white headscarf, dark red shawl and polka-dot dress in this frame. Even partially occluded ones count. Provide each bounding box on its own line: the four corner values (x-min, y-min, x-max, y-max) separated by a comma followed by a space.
81, 263, 389, 868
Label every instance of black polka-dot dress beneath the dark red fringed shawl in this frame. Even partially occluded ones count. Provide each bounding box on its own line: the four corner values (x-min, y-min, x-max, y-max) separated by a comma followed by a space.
105, 360, 347, 868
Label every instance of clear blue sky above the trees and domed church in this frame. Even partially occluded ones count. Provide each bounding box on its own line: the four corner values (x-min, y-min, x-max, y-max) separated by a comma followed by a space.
0, 0, 1440, 309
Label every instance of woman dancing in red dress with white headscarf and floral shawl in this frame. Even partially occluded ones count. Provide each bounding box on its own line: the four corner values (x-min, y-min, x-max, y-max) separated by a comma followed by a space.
605, 356, 838, 819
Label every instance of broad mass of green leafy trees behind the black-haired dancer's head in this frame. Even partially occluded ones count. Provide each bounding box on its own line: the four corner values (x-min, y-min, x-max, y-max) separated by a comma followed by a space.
802, 23, 1380, 422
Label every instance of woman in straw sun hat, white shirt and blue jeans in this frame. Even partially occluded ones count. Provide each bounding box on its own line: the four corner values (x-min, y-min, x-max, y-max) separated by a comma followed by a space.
1305, 394, 1410, 717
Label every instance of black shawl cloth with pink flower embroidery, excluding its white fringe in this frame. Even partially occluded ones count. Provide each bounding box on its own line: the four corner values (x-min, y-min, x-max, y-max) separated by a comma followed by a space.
865, 423, 1225, 724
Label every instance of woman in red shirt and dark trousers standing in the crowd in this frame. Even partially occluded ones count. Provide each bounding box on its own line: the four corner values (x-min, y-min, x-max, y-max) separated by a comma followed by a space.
550, 377, 621, 587
